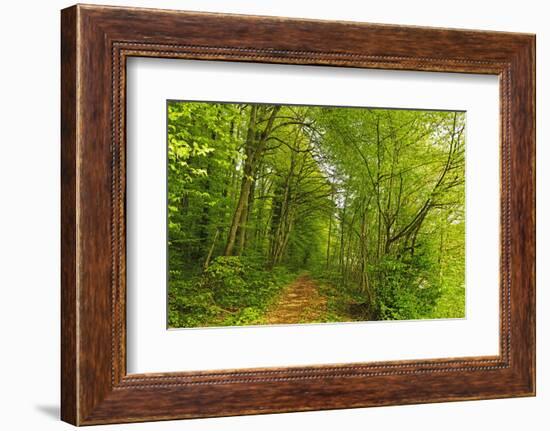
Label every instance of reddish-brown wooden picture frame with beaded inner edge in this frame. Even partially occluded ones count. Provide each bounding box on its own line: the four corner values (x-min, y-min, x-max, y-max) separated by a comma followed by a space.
61, 5, 535, 425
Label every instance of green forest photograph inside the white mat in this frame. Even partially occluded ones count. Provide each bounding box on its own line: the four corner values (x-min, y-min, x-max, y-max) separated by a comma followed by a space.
167, 100, 466, 328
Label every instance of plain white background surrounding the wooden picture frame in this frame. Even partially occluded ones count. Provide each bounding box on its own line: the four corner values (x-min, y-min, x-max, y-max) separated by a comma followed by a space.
0, 0, 550, 431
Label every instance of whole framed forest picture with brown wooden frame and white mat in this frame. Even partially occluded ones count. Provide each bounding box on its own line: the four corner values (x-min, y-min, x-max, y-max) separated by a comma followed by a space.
61, 5, 535, 425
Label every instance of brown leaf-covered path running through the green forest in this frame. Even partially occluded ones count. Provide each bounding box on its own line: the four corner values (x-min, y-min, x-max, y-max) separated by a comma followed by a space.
264, 274, 327, 324
